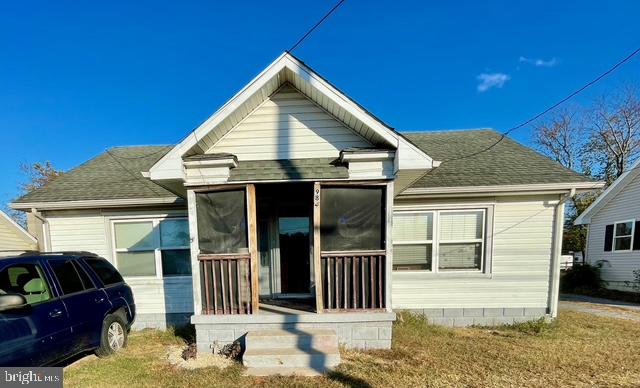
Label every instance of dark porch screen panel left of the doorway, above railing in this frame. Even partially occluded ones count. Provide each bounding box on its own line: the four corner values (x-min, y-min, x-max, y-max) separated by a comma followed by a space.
196, 189, 249, 253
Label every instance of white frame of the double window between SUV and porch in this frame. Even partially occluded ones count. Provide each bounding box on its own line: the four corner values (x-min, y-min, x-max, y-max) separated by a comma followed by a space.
111, 216, 191, 280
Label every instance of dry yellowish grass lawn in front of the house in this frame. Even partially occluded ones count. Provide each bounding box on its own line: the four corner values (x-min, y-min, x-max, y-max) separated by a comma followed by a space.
65, 311, 640, 387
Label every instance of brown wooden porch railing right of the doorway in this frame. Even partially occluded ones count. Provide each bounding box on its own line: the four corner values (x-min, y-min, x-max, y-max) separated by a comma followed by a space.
320, 251, 386, 311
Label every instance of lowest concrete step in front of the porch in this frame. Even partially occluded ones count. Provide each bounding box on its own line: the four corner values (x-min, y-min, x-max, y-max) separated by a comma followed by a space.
242, 347, 340, 372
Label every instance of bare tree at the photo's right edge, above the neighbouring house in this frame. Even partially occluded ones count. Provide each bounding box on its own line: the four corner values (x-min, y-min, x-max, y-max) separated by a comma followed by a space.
588, 87, 640, 183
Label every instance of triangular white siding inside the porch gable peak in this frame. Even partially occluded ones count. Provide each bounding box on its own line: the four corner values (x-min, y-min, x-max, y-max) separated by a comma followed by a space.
207, 86, 371, 161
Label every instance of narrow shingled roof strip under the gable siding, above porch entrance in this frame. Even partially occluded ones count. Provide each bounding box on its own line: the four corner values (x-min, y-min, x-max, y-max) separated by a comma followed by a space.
229, 158, 349, 182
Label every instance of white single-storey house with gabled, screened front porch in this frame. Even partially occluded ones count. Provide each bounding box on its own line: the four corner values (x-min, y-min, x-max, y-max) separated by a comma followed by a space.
12, 53, 601, 350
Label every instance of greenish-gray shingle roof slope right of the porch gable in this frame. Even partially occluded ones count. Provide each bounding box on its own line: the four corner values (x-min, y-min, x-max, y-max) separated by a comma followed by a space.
402, 129, 592, 188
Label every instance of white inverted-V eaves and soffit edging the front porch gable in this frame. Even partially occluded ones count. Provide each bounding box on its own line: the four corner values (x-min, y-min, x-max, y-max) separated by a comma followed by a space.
149, 53, 434, 180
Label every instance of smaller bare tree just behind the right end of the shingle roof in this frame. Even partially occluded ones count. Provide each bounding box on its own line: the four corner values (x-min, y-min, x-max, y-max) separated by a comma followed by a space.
534, 108, 586, 170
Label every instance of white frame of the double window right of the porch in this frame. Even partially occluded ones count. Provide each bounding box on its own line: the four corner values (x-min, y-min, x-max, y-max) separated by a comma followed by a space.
392, 203, 495, 277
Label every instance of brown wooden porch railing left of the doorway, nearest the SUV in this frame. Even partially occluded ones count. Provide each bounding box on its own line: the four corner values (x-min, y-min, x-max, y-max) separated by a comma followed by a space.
198, 254, 253, 314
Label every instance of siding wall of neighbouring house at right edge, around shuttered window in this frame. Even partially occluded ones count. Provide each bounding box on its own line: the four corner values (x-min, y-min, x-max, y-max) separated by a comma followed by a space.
586, 175, 640, 291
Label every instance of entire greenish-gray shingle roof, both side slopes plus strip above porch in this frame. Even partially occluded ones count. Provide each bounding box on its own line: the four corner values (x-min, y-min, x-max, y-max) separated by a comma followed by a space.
14, 130, 591, 203
